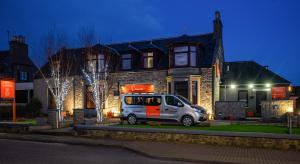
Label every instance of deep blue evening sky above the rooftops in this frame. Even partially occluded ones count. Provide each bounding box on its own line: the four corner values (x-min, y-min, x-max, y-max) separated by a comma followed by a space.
0, 0, 300, 85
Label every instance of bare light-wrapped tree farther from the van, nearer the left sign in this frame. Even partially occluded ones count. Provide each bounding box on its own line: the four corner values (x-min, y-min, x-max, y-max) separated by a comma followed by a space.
39, 31, 73, 121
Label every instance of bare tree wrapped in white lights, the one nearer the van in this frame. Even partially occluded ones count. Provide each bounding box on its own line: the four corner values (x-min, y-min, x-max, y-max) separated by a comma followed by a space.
79, 29, 118, 123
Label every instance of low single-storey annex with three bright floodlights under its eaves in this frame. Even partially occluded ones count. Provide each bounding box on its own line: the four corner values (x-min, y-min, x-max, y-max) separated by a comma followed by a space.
216, 61, 292, 119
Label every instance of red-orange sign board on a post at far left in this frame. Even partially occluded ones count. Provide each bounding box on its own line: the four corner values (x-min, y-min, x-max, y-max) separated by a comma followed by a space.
0, 80, 15, 99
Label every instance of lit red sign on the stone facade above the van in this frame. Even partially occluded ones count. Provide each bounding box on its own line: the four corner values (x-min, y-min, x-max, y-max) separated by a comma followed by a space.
121, 84, 154, 93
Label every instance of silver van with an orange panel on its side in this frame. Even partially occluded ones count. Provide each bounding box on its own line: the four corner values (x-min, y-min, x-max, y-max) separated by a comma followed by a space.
120, 94, 207, 126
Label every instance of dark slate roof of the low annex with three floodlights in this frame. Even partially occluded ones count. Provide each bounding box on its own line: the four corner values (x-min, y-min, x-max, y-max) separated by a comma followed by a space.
221, 61, 291, 85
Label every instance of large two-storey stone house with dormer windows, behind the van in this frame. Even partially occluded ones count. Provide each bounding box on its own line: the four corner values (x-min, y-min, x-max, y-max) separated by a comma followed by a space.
34, 12, 224, 118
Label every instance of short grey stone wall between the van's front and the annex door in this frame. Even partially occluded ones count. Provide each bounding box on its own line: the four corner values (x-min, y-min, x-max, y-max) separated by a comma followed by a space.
215, 101, 246, 119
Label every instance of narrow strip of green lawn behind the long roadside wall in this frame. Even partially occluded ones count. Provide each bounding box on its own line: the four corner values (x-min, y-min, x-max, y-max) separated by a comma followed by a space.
114, 124, 300, 134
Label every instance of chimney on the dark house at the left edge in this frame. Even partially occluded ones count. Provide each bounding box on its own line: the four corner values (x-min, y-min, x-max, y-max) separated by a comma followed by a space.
9, 35, 28, 57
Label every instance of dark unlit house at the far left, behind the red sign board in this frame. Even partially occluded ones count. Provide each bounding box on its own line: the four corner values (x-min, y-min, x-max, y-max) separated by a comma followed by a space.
0, 35, 37, 109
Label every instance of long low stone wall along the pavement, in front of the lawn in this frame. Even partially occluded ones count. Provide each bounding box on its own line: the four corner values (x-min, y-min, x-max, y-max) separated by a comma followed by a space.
75, 126, 300, 150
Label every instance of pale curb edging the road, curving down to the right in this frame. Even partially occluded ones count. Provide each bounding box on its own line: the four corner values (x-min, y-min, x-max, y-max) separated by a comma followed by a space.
0, 133, 243, 164
